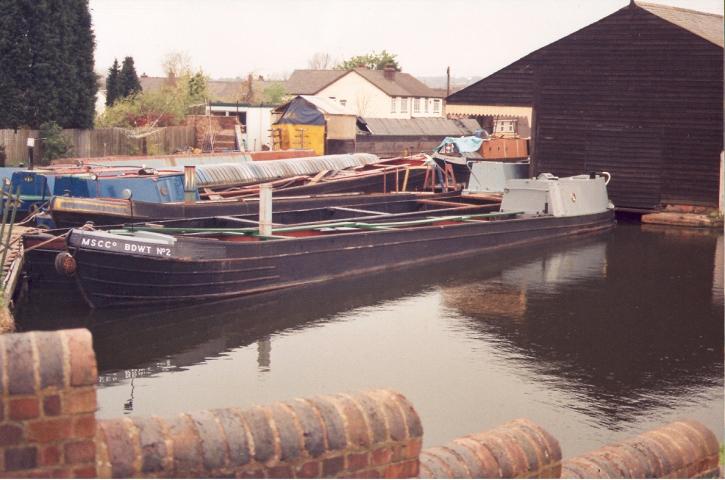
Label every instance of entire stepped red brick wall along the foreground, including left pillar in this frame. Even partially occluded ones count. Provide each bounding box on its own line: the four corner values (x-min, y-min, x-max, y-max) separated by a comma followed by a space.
0, 329, 719, 478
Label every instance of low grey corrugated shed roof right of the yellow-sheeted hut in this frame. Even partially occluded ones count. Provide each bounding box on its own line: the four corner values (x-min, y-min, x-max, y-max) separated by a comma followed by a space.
363, 117, 481, 137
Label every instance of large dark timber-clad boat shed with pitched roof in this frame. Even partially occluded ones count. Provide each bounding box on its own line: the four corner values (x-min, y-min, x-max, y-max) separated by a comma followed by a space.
446, 1, 723, 212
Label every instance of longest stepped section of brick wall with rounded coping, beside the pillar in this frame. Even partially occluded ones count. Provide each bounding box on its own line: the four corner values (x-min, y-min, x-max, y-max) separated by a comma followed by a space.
97, 390, 423, 478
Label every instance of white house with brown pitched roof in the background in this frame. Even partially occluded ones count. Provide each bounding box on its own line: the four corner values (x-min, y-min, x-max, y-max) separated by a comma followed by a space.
287, 68, 444, 119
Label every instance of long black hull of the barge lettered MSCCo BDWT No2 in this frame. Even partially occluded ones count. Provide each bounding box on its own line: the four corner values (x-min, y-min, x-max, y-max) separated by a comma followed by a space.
68, 211, 614, 308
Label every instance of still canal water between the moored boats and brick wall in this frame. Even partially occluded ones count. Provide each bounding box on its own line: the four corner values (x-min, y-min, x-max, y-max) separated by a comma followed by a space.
17, 223, 724, 456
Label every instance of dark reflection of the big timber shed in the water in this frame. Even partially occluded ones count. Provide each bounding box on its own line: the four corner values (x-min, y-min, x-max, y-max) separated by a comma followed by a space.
443, 228, 723, 428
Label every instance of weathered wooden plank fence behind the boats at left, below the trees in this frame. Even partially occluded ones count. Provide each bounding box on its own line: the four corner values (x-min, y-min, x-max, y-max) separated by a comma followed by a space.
0, 126, 195, 166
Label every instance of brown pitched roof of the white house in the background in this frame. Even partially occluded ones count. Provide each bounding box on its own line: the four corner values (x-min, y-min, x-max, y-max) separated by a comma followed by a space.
287, 68, 445, 98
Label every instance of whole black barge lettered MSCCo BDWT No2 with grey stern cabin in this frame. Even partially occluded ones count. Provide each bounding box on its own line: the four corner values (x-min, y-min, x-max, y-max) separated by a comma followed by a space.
46, 173, 614, 308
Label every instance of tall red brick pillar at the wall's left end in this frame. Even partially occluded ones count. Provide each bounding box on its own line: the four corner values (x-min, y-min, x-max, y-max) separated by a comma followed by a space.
0, 330, 96, 477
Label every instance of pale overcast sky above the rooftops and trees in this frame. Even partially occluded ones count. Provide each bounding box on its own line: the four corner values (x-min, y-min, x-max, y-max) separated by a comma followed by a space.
90, 0, 723, 78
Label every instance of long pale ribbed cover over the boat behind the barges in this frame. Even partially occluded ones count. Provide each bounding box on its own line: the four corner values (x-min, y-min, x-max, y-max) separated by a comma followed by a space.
196, 153, 380, 187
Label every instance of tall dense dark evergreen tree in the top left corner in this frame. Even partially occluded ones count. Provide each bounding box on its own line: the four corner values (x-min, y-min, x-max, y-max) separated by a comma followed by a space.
0, 0, 98, 128
